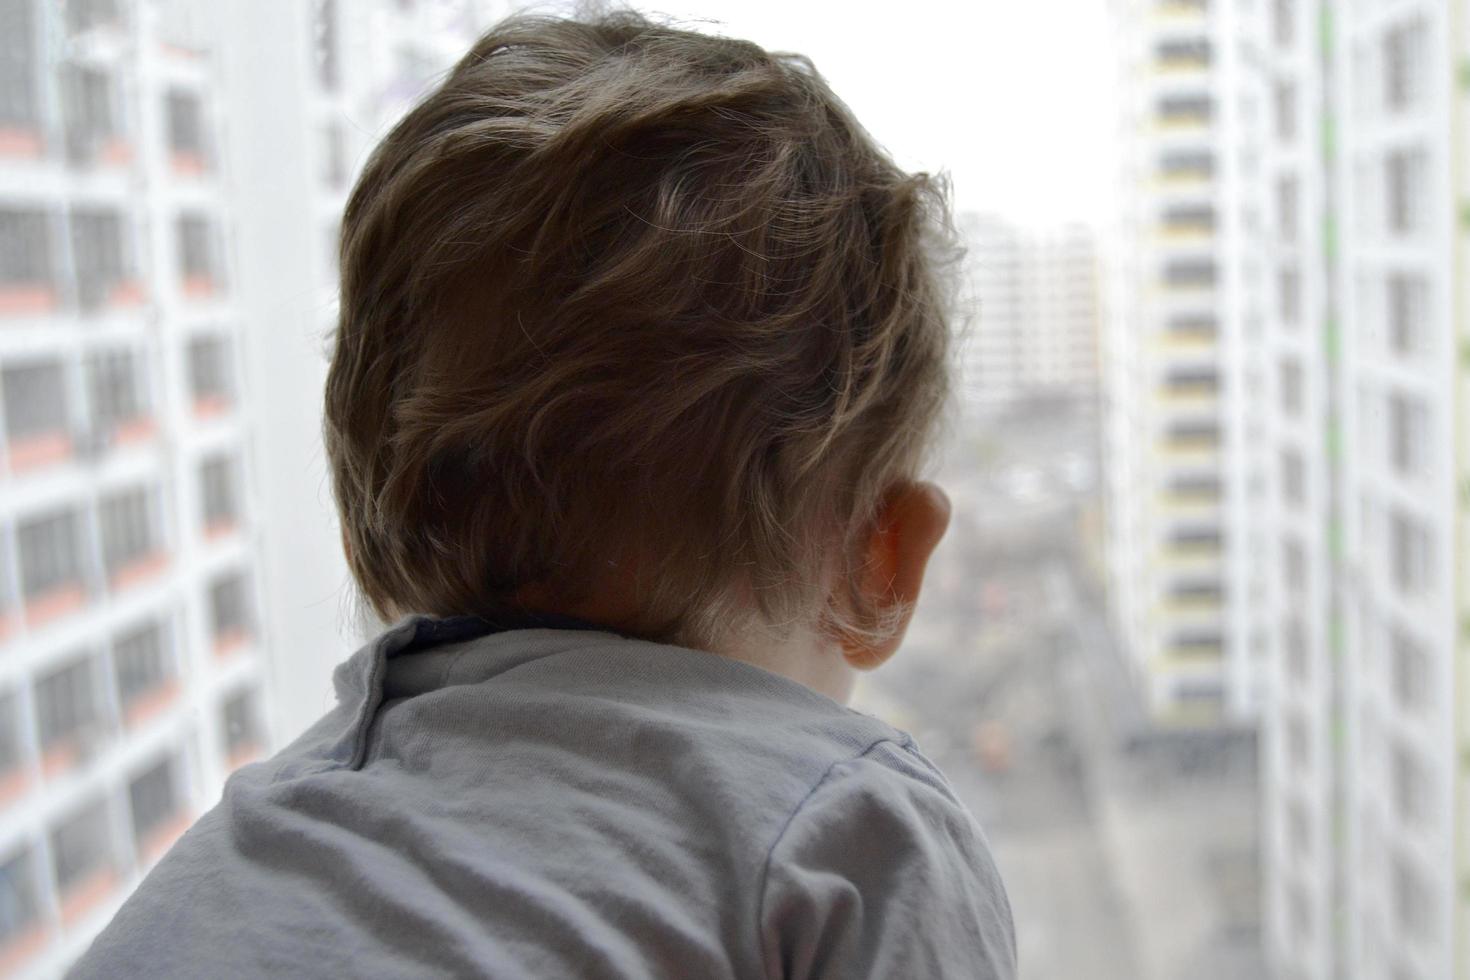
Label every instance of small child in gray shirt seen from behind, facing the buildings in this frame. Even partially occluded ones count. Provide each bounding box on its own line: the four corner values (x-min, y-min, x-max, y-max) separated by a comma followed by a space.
75, 13, 1016, 979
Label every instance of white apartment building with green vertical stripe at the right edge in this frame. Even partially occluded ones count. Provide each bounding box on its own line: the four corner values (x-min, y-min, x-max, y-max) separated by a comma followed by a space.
1261, 0, 1470, 980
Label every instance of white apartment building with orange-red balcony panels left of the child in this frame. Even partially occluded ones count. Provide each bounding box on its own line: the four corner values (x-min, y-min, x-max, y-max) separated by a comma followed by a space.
0, 0, 508, 976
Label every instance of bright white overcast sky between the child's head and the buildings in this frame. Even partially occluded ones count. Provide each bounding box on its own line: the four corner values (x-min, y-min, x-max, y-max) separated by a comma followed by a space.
634, 0, 1113, 222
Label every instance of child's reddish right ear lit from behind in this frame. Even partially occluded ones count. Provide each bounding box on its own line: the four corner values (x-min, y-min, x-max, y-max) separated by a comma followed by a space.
842, 482, 951, 670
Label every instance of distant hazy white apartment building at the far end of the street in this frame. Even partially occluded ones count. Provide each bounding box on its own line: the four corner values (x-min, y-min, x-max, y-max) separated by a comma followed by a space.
958, 215, 1098, 419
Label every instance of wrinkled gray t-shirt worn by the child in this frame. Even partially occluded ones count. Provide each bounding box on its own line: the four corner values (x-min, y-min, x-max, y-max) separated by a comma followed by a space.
72, 617, 1016, 980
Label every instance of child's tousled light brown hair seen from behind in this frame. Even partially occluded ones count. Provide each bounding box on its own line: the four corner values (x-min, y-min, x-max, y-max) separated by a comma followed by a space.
325, 12, 956, 646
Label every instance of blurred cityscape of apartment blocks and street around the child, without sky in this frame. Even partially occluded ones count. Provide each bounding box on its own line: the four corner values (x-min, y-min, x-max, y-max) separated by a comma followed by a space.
0, 0, 1470, 980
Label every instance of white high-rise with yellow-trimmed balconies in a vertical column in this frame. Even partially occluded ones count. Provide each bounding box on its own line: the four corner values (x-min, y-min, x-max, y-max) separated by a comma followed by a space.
1103, 0, 1266, 729
